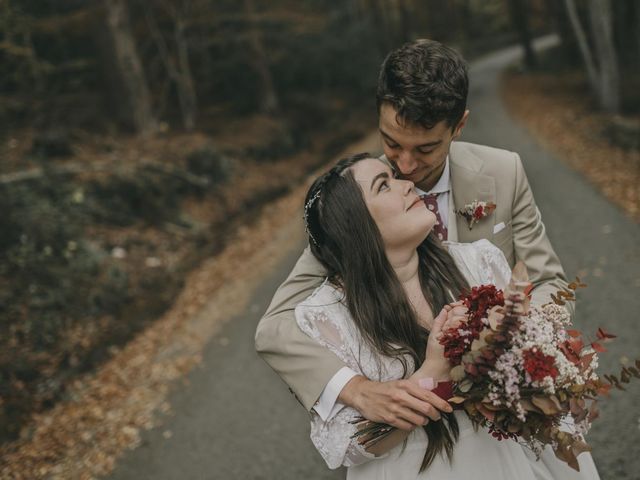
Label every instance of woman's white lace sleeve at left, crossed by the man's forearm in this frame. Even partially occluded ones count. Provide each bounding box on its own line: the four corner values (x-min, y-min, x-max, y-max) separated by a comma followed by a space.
295, 287, 376, 469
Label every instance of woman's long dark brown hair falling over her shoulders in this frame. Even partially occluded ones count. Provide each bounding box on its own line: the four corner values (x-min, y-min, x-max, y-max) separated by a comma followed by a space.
305, 153, 469, 471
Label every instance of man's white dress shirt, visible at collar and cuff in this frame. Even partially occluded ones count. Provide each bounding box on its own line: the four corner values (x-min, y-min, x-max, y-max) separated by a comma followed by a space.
313, 156, 451, 421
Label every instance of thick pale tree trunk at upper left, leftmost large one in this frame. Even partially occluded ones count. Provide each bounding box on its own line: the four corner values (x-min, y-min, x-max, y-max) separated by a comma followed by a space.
104, 0, 157, 135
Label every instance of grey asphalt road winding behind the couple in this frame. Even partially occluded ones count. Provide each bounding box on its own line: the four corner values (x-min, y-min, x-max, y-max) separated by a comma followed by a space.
109, 40, 640, 480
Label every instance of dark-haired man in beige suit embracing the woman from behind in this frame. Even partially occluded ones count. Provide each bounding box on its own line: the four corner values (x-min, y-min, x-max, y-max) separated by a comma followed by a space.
256, 40, 566, 430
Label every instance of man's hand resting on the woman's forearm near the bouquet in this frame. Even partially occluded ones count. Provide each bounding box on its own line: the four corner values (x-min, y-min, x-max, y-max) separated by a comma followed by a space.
338, 375, 453, 431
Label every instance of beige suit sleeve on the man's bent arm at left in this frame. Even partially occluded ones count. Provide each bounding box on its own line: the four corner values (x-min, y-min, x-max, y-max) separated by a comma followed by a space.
255, 247, 345, 410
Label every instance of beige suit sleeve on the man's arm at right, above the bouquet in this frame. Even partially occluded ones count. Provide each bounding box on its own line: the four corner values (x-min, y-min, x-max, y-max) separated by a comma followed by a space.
512, 154, 573, 314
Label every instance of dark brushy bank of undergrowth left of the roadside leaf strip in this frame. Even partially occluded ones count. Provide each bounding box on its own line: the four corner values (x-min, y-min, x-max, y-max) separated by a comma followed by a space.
0, 122, 369, 441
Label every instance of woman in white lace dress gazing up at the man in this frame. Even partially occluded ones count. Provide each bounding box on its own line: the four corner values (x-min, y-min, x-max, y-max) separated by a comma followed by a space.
295, 154, 599, 480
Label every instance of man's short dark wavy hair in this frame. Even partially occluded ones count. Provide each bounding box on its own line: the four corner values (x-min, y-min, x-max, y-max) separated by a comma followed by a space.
376, 39, 469, 129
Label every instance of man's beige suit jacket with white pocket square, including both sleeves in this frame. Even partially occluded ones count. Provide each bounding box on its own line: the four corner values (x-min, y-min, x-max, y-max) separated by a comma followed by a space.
255, 142, 566, 410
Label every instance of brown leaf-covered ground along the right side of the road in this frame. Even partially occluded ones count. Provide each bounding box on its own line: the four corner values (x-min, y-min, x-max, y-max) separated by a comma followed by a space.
503, 71, 640, 221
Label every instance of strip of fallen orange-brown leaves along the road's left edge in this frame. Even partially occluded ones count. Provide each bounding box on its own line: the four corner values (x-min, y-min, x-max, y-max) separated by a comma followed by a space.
0, 162, 305, 480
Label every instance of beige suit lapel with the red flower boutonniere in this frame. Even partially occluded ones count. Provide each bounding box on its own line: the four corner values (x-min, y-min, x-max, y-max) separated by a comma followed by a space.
449, 142, 496, 243
